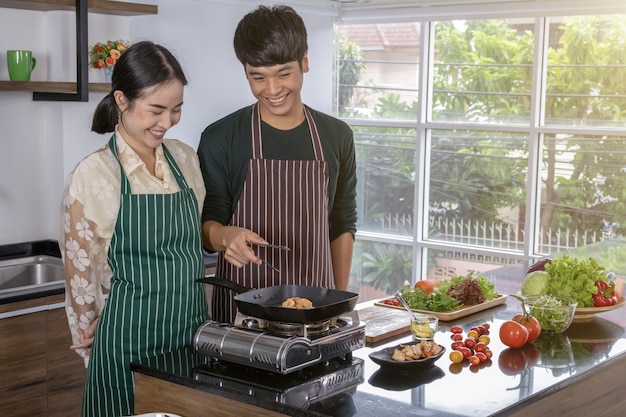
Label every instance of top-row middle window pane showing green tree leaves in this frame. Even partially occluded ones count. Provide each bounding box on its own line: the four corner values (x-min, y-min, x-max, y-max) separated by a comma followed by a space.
432, 19, 535, 124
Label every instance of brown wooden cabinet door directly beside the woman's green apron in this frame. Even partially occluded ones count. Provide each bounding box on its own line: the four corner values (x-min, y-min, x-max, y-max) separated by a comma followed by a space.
46, 296, 86, 417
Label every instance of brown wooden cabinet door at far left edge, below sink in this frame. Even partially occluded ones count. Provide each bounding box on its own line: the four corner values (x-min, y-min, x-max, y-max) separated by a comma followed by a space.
0, 312, 46, 417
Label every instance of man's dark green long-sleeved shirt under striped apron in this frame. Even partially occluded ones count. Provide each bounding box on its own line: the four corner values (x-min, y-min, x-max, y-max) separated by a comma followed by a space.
198, 106, 357, 241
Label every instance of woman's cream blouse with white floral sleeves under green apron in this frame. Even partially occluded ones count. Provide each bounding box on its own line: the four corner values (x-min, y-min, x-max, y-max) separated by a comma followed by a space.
59, 133, 206, 359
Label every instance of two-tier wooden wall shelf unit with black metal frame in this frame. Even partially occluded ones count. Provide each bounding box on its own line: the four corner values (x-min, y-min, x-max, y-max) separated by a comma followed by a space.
0, 0, 158, 101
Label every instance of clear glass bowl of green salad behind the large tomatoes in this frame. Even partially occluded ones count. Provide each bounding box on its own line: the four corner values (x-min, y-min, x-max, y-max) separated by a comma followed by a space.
524, 295, 578, 333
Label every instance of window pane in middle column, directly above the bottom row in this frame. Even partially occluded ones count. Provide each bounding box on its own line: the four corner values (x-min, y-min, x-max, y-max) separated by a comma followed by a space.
427, 130, 528, 250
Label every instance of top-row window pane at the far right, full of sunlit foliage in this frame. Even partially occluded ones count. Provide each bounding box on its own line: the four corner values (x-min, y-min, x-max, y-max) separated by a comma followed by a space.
545, 15, 626, 128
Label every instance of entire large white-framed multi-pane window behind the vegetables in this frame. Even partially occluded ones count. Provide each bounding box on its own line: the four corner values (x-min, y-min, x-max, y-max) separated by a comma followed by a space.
336, 15, 626, 300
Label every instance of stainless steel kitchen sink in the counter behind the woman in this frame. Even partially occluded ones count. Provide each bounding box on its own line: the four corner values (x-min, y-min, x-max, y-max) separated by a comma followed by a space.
0, 255, 65, 298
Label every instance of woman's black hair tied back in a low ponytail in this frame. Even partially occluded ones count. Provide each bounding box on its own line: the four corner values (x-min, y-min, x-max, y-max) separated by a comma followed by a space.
91, 41, 187, 133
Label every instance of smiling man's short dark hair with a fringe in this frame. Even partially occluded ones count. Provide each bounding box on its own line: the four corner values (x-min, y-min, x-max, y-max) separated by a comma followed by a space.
233, 5, 308, 67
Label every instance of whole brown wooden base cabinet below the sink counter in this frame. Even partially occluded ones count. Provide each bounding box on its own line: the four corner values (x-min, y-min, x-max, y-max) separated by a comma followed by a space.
0, 294, 85, 417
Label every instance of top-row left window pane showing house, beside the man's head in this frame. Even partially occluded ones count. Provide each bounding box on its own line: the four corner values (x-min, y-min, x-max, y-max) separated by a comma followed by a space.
337, 22, 420, 120
